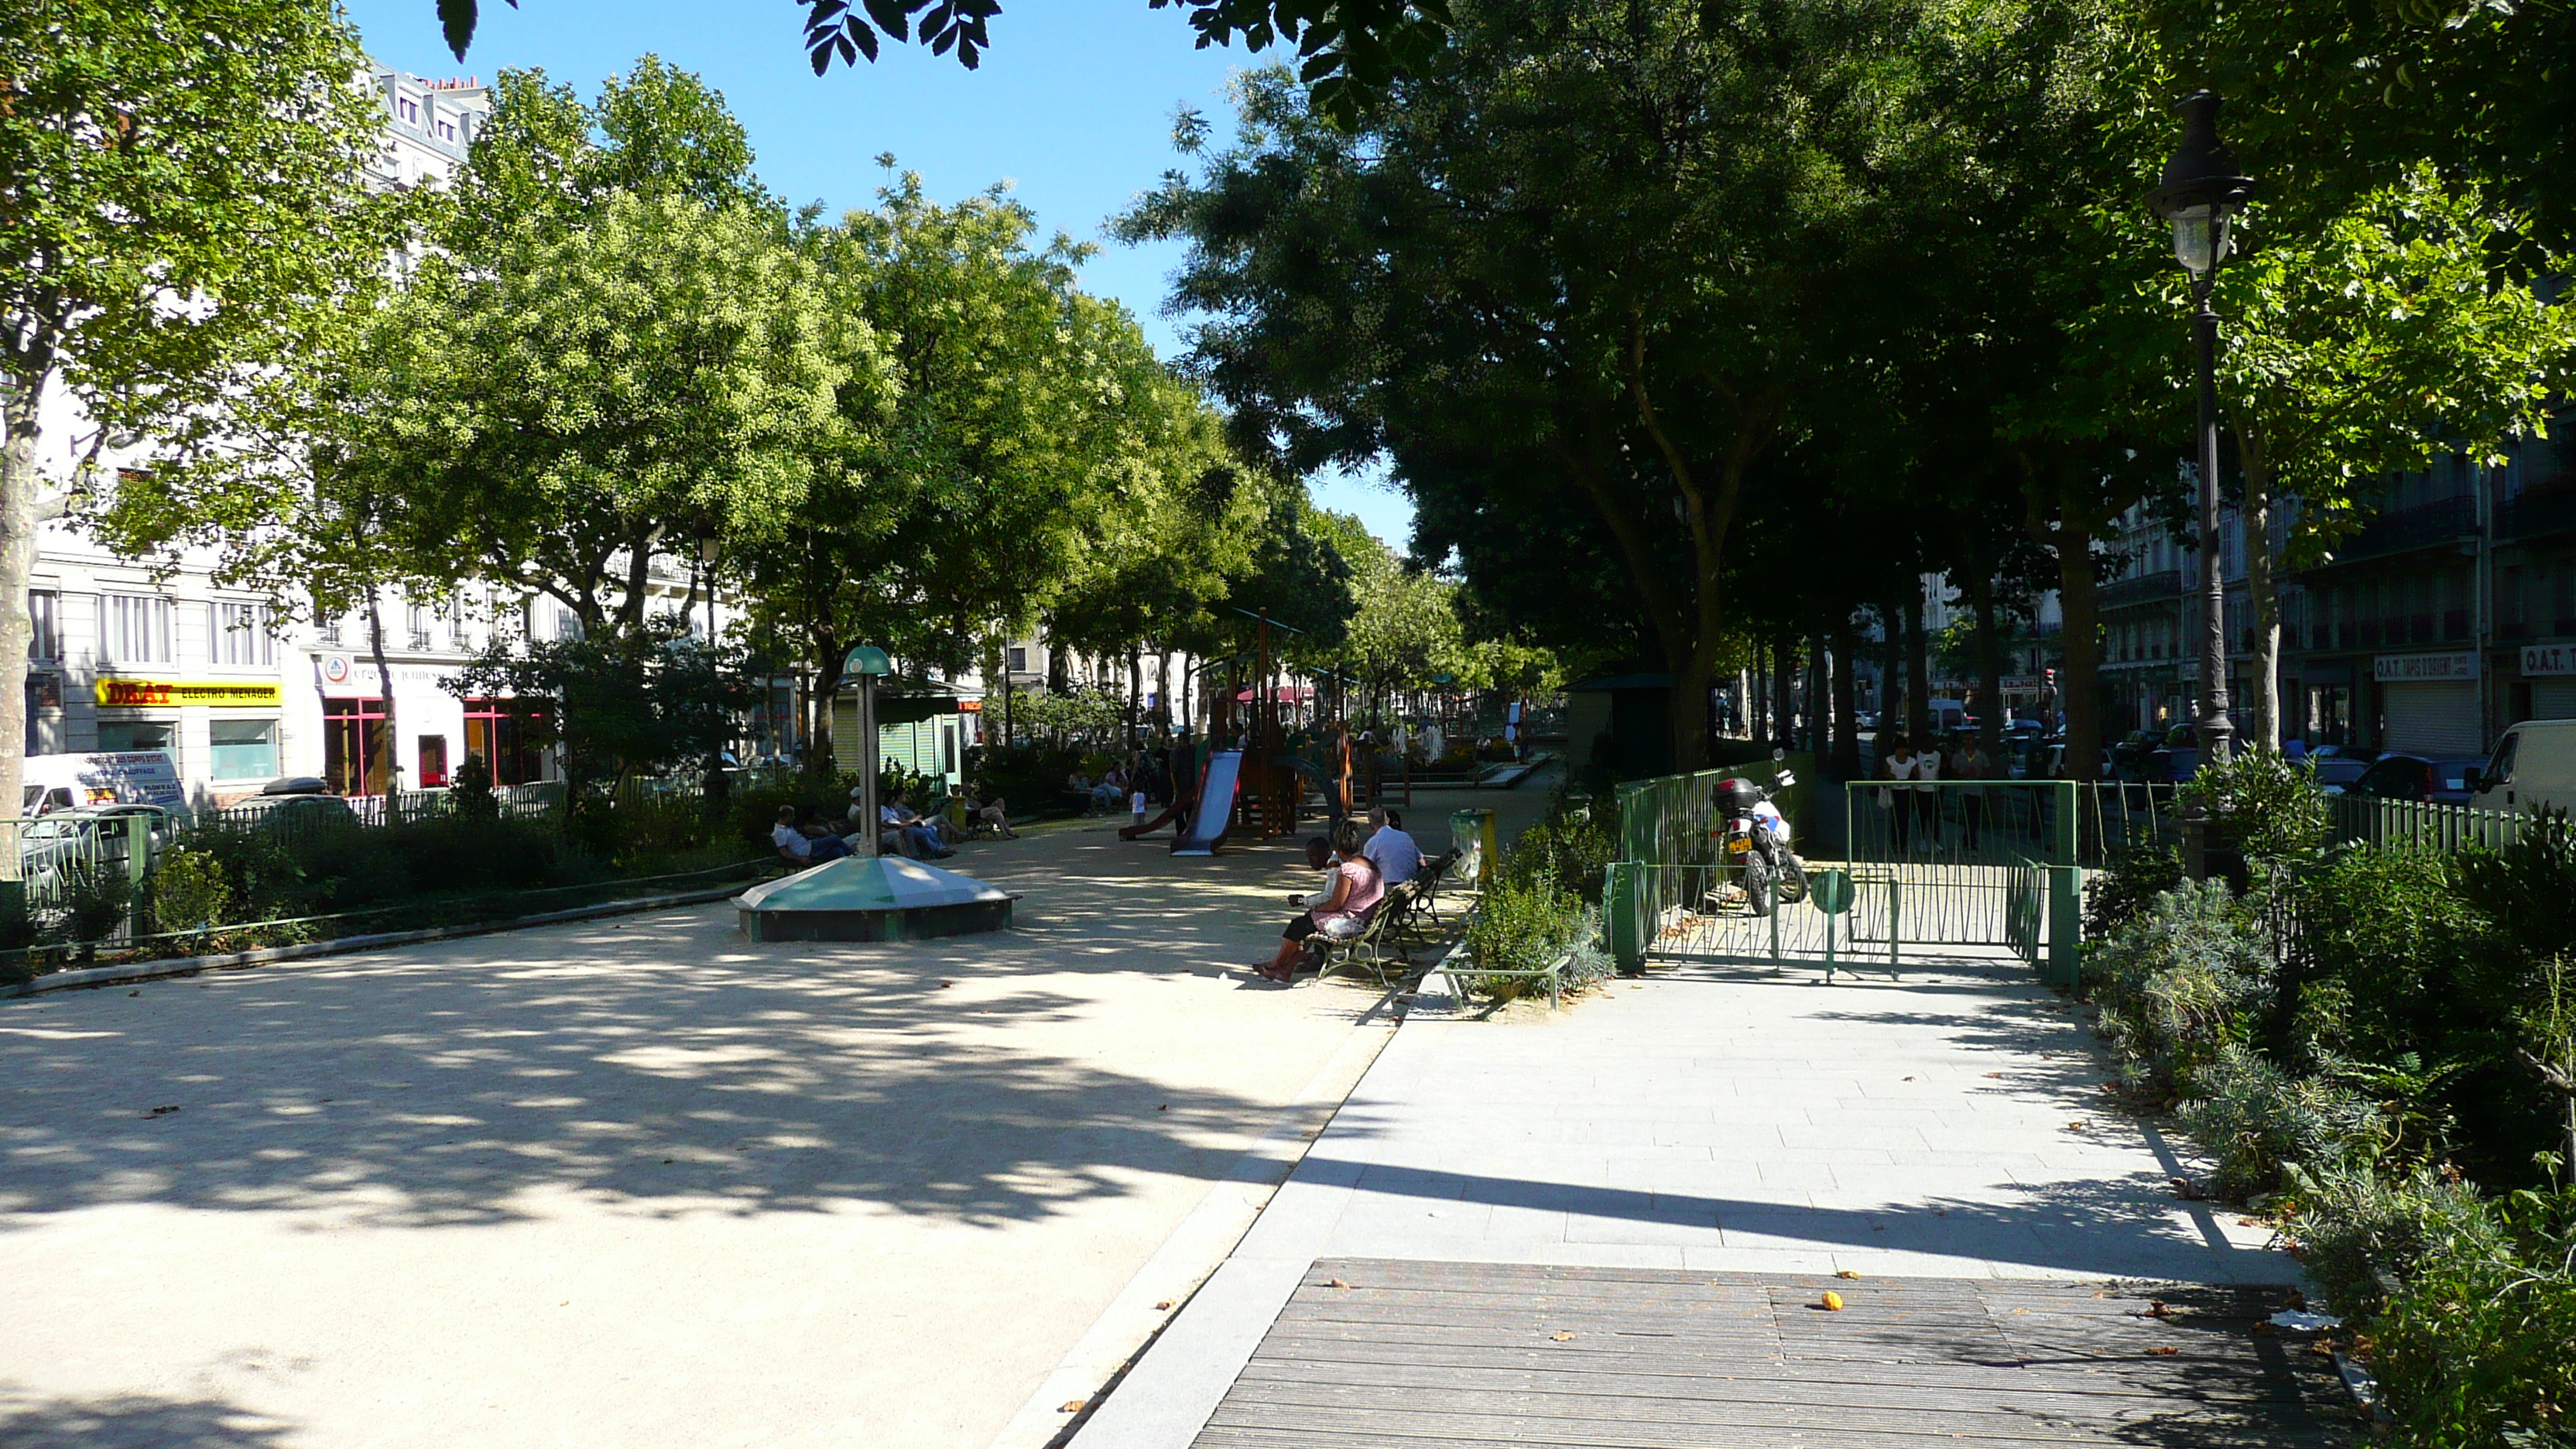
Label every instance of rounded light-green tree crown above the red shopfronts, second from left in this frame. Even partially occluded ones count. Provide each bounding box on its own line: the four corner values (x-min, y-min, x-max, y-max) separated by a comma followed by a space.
399, 194, 875, 632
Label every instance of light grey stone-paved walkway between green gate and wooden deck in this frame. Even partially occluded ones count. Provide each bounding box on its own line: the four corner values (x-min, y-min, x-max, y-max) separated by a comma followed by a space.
1074, 957, 2324, 1449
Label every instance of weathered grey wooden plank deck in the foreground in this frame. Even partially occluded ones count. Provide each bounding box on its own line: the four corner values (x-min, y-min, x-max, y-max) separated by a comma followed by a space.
1195, 1259, 2357, 1449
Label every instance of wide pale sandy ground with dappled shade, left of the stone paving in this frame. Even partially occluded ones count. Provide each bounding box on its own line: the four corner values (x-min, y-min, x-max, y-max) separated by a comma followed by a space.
0, 823, 1452, 1449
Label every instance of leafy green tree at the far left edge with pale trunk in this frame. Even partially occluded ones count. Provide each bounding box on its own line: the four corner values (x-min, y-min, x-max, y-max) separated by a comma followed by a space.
0, 0, 386, 824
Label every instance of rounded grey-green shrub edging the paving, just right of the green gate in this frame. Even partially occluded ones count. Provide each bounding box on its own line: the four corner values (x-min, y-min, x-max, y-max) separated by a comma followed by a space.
2084, 882, 2272, 1096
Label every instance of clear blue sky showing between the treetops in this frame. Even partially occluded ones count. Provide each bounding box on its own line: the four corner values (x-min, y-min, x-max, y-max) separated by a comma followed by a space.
348, 0, 1412, 549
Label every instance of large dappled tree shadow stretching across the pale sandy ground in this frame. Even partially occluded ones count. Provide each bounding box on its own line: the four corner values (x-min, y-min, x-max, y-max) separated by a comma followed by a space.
0, 835, 1375, 1225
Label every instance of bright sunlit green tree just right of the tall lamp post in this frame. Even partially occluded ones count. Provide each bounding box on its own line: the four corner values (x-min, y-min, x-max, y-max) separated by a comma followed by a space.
2167, 165, 2576, 748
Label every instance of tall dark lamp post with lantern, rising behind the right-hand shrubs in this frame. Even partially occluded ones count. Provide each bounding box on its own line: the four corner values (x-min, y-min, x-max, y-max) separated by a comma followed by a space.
2146, 91, 2254, 763
